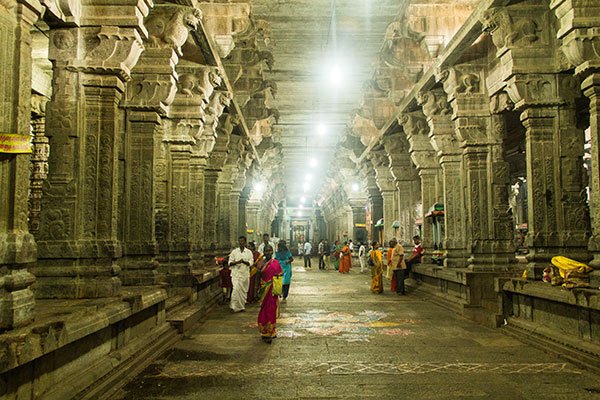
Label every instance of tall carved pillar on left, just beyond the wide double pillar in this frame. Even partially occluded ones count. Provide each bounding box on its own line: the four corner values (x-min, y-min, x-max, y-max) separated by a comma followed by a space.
120, 4, 198, 285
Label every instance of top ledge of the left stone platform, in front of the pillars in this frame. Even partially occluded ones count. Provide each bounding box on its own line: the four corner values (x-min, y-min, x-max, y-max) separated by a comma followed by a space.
0, 287, 167, 373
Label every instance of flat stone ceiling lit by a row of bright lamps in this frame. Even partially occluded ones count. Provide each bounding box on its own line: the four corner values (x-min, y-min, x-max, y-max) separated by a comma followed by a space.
252, 0, 408, 206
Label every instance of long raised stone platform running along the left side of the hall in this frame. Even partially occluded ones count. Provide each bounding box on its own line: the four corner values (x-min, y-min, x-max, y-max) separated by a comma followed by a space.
0, 268, 221, 400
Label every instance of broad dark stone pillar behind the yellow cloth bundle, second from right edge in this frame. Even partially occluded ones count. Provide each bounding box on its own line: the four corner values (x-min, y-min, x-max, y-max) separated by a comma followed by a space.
510, 75, 590, 278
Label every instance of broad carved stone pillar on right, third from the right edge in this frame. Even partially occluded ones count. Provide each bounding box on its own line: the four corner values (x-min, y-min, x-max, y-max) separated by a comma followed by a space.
437, 62, 514, 270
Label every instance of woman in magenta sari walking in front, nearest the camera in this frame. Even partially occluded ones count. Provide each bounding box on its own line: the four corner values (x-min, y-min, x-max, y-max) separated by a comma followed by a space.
257, 245, 283, 344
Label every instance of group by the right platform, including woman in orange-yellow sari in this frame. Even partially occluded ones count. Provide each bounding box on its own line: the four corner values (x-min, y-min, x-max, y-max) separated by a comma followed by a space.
368, 236, 423, 295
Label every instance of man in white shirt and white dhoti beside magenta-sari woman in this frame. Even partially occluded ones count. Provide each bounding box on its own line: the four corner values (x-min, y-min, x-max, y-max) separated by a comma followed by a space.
229, 236, 254, 312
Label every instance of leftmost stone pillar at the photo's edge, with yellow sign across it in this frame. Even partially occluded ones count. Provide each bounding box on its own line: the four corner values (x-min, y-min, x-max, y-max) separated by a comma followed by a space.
0, 0, 42, 330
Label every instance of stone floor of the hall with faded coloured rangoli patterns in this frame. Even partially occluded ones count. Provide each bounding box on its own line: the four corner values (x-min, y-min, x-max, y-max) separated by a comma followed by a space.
114, 260, 600, 400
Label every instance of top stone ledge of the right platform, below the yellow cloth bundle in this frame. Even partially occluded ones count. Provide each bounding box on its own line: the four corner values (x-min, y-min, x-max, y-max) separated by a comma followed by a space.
502, 278, 600, 311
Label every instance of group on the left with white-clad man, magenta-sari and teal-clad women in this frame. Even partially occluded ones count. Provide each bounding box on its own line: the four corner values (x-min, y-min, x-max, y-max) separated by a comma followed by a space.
221, 234, 293, 343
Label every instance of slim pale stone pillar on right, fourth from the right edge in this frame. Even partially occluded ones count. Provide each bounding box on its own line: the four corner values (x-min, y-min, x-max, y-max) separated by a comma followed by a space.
419, 88, 467, 267
